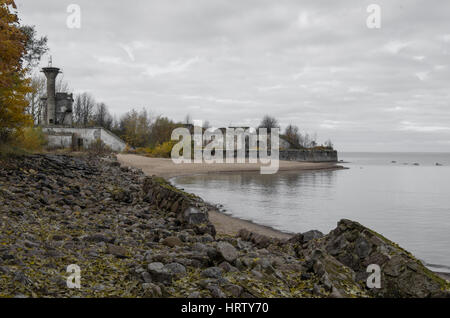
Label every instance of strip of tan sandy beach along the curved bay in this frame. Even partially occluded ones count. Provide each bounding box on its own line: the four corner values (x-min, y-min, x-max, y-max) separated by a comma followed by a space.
117, 154, 342, 239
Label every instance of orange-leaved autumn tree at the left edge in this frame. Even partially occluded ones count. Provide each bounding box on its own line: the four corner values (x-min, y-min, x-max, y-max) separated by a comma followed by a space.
0, 0, 32, 141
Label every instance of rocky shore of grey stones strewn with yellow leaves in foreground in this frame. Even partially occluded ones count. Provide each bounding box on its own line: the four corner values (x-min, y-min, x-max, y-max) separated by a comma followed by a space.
0, 155, 450, 298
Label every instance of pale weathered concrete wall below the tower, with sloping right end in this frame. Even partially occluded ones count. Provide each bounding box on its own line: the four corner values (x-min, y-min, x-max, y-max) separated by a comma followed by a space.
42, 126, 126, 152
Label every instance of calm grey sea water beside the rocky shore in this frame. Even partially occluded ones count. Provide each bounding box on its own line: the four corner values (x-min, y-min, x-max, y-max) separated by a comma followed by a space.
172, 153, 450, 272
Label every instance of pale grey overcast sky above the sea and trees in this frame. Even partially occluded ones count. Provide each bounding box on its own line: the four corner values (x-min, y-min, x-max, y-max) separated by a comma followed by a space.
16, 0, 450, 152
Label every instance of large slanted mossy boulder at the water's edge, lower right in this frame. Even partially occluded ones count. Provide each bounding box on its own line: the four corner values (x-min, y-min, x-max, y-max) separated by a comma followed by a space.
308, 220, 450, 297
